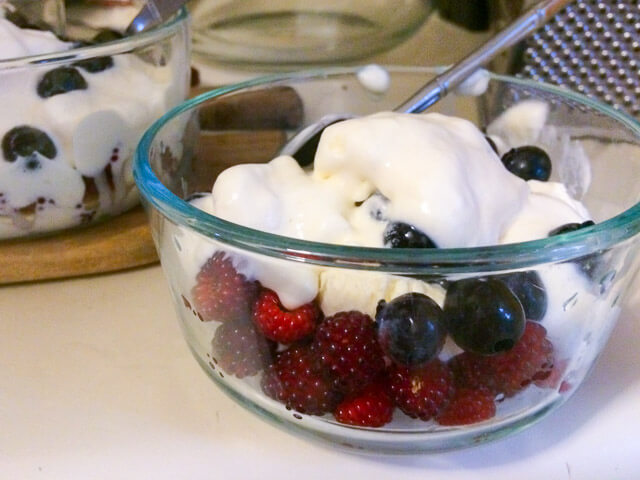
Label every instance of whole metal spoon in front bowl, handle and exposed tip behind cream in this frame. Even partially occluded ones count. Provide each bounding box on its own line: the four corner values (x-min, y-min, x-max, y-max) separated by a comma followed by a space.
280, 0, 573, 166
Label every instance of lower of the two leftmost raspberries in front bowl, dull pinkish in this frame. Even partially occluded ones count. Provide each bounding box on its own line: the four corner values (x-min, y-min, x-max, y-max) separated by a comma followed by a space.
211, 320, 276, 378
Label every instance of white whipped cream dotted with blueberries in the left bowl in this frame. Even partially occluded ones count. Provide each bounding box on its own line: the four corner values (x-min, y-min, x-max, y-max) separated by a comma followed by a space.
0, 17, 188, 239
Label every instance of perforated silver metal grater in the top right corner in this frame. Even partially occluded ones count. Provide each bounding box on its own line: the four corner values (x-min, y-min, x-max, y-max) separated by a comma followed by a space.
509, 0, 640, 118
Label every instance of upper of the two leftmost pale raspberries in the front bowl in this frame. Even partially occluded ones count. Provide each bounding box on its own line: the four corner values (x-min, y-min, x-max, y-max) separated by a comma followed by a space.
191, 251, 258, 322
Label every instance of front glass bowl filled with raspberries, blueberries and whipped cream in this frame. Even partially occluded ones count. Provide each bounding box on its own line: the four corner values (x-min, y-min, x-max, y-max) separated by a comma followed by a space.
134, 67, 640, 453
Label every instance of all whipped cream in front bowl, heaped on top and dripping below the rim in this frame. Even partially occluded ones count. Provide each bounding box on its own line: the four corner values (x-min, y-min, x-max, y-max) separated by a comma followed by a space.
184, 107, 590, 315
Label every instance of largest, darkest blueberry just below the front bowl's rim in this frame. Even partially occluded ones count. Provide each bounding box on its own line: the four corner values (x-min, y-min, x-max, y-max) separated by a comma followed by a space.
444, 278, 526, 355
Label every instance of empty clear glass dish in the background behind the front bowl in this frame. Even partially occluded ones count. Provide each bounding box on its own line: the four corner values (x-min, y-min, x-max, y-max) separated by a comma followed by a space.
188, 0, 433, 67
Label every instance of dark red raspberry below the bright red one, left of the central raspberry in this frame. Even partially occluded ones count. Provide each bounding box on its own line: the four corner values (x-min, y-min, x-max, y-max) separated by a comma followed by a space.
262, 345, 341, 415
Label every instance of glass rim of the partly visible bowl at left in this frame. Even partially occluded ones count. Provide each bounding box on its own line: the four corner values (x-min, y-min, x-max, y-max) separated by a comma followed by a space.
0, 7, 190, 70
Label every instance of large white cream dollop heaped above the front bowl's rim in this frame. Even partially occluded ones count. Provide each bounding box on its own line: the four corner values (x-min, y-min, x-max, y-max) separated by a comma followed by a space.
212, 112, 544, 248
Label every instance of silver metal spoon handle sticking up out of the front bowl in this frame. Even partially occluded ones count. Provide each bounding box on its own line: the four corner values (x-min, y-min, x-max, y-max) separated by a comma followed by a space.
396, 0, 573, 113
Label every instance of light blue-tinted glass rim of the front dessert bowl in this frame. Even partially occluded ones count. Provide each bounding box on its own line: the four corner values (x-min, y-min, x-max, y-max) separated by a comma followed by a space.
133, 66, 640, 276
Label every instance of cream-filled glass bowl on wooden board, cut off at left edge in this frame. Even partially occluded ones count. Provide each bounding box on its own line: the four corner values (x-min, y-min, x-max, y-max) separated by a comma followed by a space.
0, 9, 190, 240
